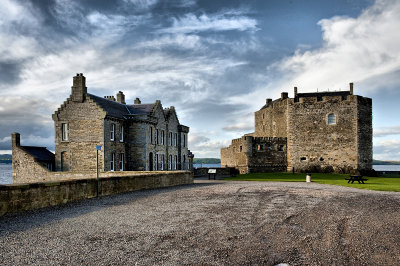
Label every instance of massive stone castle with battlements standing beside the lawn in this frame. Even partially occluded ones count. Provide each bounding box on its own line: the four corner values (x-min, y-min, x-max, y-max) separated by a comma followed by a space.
221, 83, 372, 173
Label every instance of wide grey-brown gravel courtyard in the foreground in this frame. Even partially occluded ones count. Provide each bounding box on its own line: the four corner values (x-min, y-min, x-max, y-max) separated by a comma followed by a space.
0, 180, 400, 265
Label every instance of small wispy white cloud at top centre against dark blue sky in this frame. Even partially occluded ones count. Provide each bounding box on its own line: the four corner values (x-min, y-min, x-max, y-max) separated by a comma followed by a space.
158, 12, 258, 34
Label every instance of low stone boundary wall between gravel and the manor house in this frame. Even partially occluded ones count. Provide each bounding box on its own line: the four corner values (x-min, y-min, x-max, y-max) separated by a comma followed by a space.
0, 171, 193, 215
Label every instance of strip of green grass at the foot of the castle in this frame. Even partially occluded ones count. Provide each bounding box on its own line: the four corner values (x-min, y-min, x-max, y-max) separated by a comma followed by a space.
224, 173, 400, 192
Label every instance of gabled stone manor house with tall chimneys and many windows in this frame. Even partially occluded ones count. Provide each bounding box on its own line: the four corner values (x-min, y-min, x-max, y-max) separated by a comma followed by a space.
12, 73, 193, 182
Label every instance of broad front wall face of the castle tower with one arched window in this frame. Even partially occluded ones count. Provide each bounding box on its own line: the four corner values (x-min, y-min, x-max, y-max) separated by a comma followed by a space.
288, 95, 358, 173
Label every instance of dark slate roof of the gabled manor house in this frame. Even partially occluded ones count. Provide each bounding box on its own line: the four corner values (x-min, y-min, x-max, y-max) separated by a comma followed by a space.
88, 93, 154, 119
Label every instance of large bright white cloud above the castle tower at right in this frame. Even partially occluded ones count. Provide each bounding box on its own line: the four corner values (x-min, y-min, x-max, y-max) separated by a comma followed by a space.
277, 0, 400, 91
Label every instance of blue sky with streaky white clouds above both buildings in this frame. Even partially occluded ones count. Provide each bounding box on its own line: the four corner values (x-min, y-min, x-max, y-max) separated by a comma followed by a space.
0, 0, 400, 160
